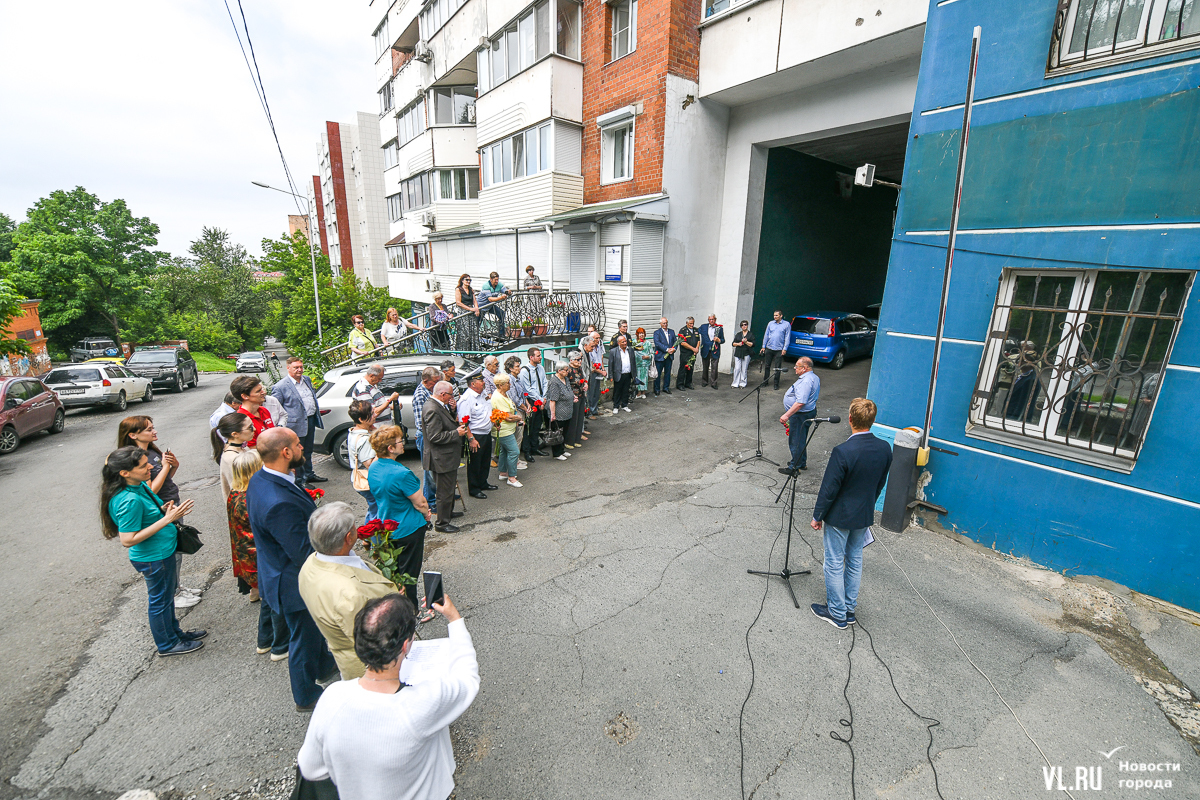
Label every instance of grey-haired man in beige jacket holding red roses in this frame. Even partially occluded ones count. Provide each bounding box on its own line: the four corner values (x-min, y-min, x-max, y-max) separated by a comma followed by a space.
300, 503, 398, 680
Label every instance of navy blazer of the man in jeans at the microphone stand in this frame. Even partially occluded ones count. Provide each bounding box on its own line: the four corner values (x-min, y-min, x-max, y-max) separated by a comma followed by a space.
812, 433, 892, 530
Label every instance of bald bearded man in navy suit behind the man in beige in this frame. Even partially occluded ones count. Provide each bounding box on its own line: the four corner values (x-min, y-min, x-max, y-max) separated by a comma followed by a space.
246, 428, 338, 714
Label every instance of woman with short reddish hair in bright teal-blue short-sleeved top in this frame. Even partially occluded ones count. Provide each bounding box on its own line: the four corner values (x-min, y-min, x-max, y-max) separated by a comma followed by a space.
367, 425, 433, 622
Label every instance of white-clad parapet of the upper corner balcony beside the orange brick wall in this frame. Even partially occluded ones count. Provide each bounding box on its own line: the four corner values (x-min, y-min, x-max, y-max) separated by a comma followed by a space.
475, 55, 583, 144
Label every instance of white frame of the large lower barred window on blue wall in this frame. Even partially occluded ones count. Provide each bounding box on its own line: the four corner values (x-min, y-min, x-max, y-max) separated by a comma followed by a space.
967, 267, 1194, 465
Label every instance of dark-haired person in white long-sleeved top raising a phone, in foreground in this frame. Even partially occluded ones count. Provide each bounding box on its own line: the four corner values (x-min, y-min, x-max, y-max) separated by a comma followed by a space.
296, 594, 479, 800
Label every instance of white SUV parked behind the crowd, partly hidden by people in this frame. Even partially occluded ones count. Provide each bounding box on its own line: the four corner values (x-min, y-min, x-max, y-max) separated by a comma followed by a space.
312, 355, 480, 469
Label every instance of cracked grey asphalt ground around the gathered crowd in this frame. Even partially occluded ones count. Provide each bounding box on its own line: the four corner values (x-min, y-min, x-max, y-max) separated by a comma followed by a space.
0, 362, 1200, 800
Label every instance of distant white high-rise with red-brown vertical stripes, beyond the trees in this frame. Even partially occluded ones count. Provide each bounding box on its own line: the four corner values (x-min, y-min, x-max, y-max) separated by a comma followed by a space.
308, 112, 389, 287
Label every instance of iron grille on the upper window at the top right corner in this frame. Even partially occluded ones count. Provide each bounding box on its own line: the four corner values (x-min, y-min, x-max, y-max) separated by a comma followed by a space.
1046, 0, 1200, 70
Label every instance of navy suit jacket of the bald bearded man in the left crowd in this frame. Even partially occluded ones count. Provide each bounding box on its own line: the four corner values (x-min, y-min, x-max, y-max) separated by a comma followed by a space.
246, 469, 317, 614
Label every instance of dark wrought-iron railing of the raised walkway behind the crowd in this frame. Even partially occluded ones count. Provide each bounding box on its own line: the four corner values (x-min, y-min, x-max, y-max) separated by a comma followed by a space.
322, 289, 605, 367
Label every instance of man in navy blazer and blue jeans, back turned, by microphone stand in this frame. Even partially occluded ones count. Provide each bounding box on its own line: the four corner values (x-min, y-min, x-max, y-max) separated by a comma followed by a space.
811, 397, 892, 630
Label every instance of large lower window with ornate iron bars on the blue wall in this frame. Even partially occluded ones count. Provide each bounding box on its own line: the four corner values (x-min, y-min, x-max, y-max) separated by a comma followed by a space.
970, 270, 1194, 459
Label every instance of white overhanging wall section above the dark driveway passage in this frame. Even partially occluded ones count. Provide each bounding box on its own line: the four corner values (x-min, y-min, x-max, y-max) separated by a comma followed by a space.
700, 0, 929, 106
